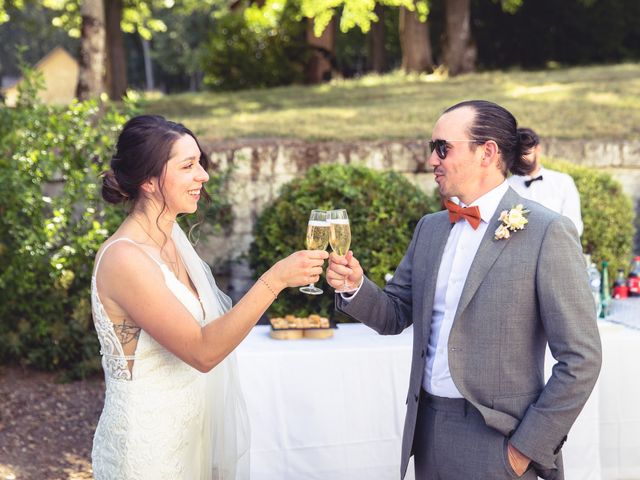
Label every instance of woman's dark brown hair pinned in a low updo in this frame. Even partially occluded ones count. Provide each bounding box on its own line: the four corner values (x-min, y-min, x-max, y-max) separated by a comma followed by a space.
102, 115, 211, 204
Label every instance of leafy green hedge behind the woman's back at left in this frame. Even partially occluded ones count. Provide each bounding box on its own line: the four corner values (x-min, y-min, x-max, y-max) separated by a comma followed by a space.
0, 70, 231, 377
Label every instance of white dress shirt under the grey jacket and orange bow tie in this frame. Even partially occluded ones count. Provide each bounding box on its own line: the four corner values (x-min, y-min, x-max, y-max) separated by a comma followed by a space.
422, 180, 509, 398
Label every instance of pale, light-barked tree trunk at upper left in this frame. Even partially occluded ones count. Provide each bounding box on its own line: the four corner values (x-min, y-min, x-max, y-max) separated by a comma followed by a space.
76, 0, 106, 101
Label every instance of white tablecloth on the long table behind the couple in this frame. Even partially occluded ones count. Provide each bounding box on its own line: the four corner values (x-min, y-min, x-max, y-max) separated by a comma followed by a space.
238, 316, 640, 480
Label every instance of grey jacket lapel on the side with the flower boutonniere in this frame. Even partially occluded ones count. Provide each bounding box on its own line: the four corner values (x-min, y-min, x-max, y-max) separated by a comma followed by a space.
453, 187, 522, 324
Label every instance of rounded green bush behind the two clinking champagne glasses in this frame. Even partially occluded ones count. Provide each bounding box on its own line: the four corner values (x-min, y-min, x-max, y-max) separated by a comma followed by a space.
250, 165, 440, 316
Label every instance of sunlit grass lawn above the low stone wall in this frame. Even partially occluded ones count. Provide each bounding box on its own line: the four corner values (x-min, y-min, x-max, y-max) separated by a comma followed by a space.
144, 63, 640, 140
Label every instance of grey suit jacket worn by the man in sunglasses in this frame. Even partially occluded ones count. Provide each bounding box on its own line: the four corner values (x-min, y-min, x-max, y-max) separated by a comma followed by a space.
336, 188, 601, 479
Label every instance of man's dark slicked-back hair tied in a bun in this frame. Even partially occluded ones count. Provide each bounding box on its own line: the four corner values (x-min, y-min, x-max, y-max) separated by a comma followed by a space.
445, 100, 537, 177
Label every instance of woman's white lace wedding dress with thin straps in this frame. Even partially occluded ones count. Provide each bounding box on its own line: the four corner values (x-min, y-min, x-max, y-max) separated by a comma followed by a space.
91, 225, 249, 480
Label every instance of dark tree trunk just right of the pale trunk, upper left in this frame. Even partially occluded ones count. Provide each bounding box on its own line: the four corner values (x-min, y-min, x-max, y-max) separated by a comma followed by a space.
105, 0, 128, 100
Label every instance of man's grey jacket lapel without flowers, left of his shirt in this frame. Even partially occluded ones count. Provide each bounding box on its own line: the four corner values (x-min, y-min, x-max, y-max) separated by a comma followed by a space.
422, 214, 453, 343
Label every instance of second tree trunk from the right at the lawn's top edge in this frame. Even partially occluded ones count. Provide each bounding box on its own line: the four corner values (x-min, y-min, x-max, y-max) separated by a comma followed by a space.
398, 3, 434, 73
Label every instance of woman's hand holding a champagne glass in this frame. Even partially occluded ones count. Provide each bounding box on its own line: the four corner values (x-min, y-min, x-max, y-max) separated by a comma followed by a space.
269, 250, 329, 289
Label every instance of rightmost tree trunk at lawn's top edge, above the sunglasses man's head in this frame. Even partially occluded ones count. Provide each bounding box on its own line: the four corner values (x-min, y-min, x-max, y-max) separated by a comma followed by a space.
444, 0, 477, 75
